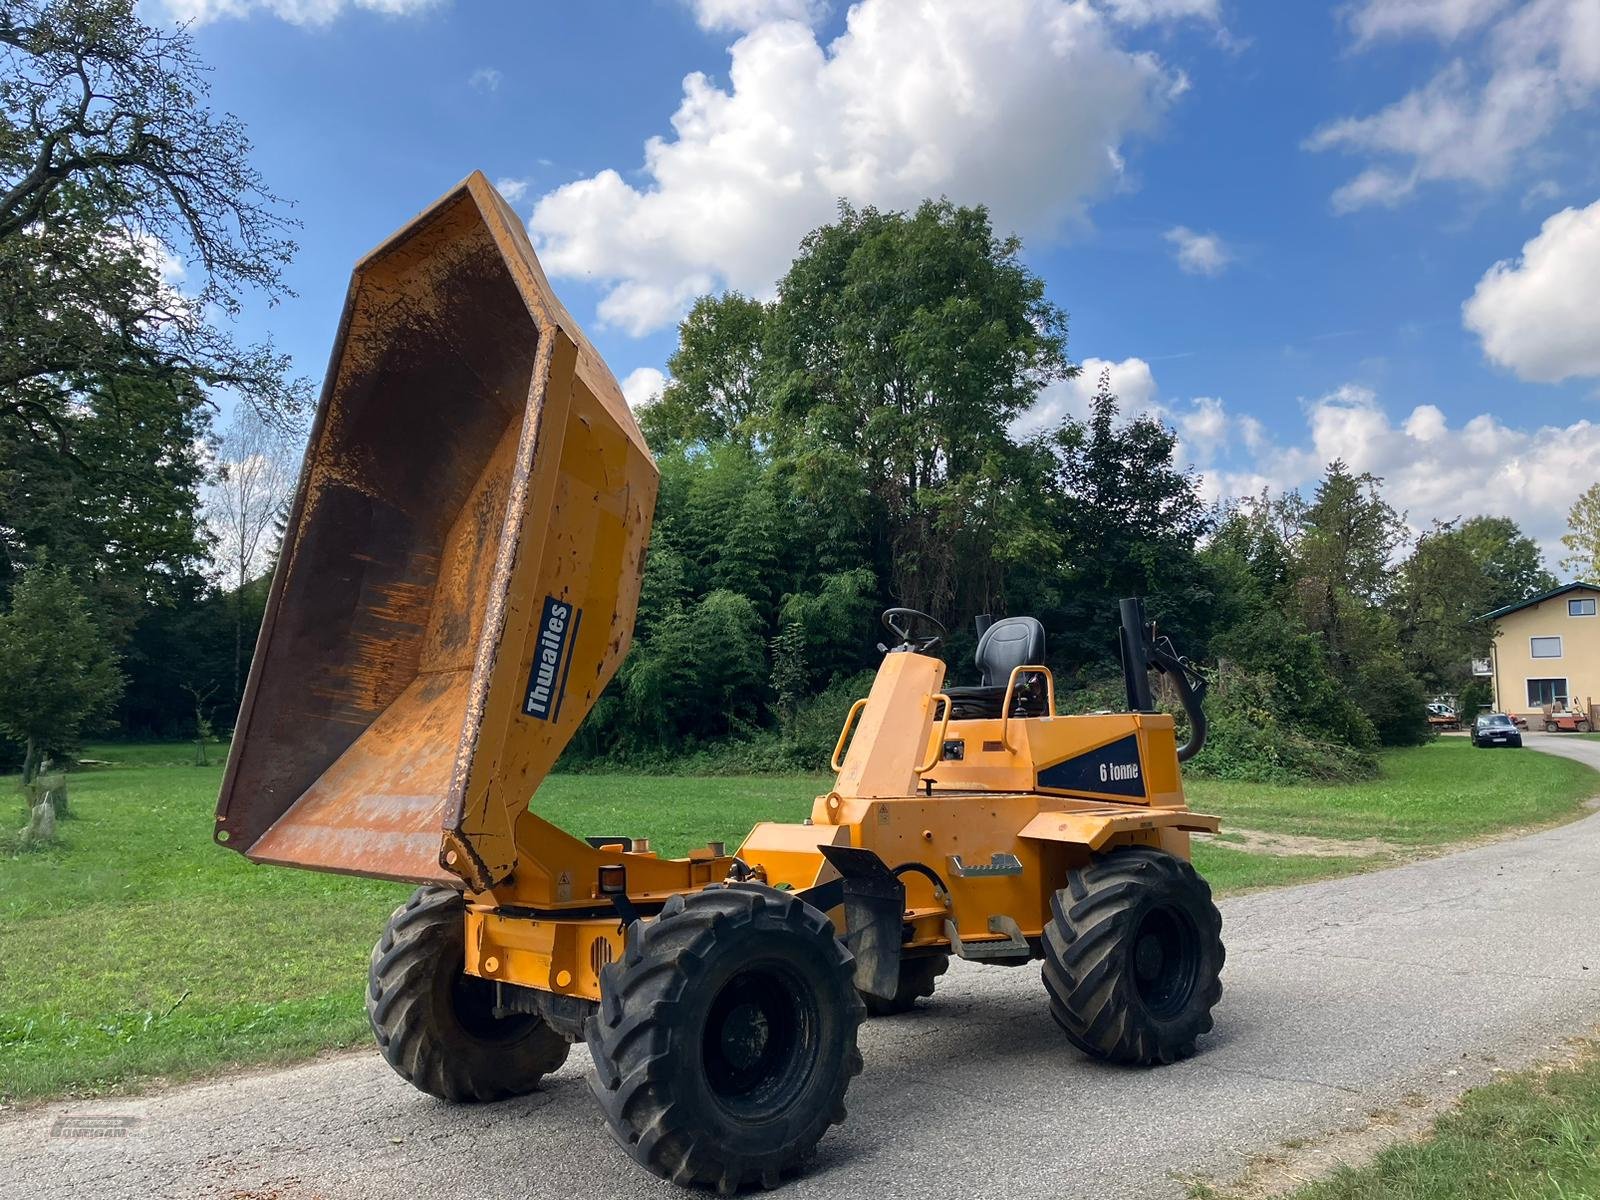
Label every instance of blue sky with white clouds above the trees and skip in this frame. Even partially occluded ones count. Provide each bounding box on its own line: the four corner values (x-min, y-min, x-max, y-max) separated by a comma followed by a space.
165, 0, 1600, 546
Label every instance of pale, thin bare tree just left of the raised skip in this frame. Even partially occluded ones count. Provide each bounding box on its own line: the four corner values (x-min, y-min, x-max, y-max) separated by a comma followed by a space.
206, 405, 294, 707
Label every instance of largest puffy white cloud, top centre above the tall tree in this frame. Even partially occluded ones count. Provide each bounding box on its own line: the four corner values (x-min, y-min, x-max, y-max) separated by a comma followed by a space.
530, 0, 1179, 334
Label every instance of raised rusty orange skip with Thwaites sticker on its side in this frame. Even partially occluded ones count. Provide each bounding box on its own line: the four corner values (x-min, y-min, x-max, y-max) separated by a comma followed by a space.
216, 174, 656, 888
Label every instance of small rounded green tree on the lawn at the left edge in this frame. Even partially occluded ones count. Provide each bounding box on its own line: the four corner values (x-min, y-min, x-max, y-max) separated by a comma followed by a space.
0, 566, 123, 782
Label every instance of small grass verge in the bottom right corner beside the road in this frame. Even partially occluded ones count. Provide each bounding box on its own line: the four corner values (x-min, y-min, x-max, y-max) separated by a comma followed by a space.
1241, 1046, 1600, 1200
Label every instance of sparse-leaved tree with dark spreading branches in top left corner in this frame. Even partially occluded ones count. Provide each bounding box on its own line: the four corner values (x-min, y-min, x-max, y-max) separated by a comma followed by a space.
0, 0, 307, 441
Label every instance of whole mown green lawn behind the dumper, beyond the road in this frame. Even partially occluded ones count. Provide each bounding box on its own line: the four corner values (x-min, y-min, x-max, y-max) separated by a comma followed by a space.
0, 741, 1600, 1101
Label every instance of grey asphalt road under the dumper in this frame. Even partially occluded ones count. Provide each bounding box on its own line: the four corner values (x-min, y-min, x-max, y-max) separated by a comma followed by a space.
0, 734, 1600, 1200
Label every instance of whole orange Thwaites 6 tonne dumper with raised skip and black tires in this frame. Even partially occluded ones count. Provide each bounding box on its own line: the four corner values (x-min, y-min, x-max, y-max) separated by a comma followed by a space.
214, 174, 1222, 1190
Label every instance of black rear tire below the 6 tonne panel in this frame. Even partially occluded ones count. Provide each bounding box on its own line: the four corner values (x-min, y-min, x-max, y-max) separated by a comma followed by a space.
1043, 846, 1224, 1066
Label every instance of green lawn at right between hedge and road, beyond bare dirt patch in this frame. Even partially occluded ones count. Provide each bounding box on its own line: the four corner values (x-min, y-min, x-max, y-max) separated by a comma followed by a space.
1186, 738, 1600, 846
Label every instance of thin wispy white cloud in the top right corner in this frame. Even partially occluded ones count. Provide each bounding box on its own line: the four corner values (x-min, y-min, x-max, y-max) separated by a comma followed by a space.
1306, 0, 1600, 211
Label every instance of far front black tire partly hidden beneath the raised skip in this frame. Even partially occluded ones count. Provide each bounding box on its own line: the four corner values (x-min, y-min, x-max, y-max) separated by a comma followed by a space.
366, 888, 571, 1102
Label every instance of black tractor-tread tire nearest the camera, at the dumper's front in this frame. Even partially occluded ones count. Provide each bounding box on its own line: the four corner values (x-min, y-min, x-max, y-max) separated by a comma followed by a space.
586, 885, 866, 1194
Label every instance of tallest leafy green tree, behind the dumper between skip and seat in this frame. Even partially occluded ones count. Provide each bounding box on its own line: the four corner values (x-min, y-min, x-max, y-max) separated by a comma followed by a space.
762, 200, 1072, 614
